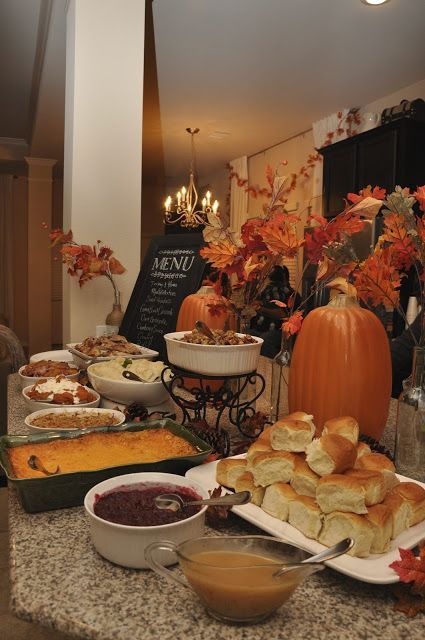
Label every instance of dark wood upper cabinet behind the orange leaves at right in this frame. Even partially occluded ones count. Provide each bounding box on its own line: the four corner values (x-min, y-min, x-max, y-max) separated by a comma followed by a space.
320, 118, 425, 217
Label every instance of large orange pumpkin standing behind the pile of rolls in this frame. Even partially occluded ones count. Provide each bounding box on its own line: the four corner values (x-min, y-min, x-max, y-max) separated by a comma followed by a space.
289, 295, 391, 440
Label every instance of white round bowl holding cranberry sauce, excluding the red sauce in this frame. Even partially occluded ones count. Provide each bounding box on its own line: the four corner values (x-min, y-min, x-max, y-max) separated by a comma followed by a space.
84, 472, 209, 569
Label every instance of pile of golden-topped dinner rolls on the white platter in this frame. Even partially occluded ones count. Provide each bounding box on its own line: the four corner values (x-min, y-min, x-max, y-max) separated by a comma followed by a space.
216, 411, 425, 558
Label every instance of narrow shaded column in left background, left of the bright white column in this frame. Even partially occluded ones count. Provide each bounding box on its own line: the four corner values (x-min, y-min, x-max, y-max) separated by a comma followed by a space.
25, 157, 56, 354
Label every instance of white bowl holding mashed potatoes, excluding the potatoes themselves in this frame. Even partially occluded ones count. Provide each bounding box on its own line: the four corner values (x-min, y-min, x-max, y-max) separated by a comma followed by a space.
87, 364, 169, 407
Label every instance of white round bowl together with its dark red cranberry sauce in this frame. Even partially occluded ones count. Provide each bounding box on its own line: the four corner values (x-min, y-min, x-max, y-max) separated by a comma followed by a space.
84, 472, 210, 569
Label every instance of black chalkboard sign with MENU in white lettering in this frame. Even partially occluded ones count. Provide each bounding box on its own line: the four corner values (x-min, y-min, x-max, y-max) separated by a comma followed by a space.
120, 234, 205, 359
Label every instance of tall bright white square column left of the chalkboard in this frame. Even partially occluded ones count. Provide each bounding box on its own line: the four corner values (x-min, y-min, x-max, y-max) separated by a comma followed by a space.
63, 0, 145, 343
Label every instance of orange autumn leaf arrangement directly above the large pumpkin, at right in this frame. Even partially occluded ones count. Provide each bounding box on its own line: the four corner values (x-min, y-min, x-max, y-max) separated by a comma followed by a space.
312, 186, 425, 344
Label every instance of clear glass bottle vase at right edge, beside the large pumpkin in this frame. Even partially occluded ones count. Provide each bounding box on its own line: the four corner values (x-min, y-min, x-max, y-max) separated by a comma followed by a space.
395, 347, 425, 482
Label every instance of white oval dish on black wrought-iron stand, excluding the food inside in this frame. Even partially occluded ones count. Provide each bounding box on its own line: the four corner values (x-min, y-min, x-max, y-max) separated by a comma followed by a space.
164, 331, 263, 376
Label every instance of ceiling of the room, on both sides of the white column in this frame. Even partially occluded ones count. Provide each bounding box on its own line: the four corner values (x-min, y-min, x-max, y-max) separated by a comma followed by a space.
0, 0, 425, 180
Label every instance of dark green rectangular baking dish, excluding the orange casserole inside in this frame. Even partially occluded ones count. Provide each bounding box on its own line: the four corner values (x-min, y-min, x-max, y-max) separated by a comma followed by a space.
0, 418, 211, 513
